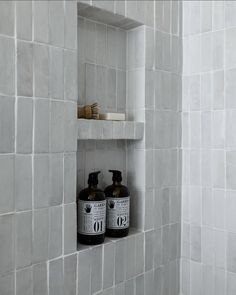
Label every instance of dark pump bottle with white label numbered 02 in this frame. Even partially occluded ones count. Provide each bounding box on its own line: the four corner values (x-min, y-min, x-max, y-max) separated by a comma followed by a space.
105, 170, 130, 238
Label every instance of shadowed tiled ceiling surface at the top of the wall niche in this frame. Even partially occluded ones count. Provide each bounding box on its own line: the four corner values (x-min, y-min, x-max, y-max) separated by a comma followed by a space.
77, 0, 143, 30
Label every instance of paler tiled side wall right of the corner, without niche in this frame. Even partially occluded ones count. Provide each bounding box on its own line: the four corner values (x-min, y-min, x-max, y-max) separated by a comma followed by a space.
181, 1, 236, 295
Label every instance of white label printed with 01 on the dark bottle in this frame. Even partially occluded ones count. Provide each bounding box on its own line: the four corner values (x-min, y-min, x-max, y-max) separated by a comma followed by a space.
78, 200, 106, 235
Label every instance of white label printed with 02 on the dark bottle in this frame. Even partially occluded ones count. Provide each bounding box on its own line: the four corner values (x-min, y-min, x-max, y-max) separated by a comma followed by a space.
107, 197, 130, 229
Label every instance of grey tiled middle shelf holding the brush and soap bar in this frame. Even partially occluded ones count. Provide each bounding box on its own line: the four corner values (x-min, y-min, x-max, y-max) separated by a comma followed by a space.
77, 119, 144, 140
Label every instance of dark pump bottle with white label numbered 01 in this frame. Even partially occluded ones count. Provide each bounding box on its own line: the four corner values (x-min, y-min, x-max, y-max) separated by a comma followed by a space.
77, 171, 106, 245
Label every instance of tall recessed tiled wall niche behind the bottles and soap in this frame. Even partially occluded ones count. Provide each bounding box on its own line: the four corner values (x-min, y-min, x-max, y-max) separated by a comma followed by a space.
77, 5, 145, 243
